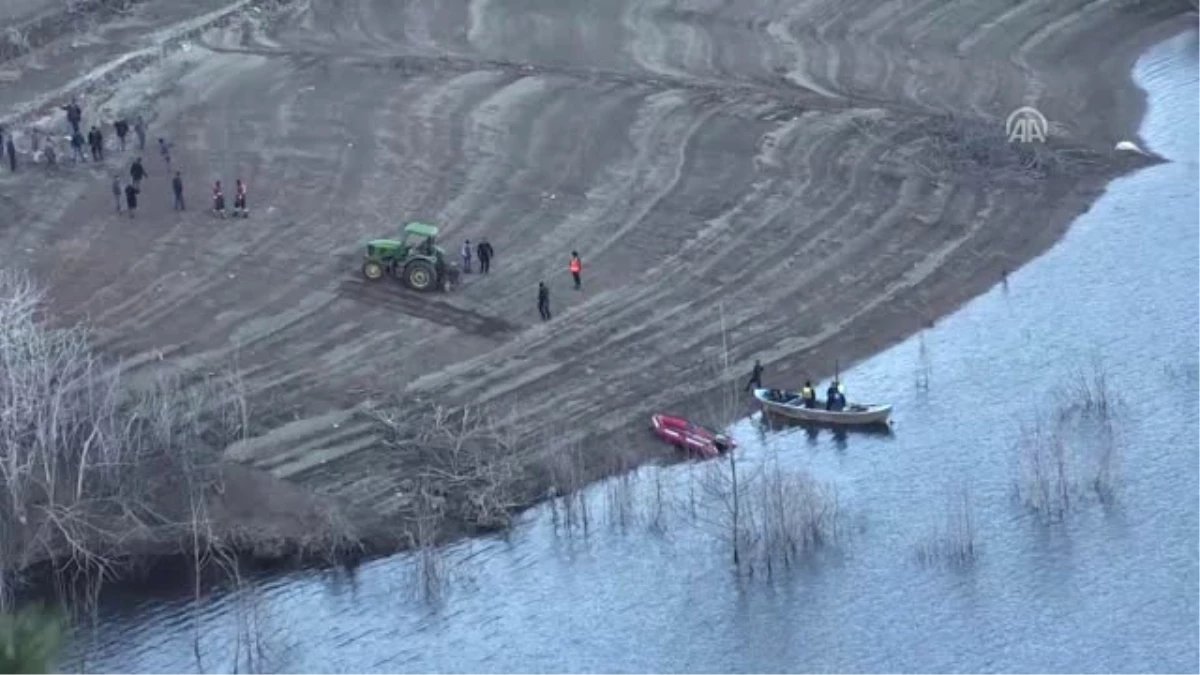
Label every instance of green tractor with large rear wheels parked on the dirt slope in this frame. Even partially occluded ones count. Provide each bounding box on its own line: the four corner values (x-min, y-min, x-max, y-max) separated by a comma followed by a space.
362, 222, 458, 291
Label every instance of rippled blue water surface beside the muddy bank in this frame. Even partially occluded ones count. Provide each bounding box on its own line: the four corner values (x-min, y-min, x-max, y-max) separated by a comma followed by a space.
63, 27, 1200, 673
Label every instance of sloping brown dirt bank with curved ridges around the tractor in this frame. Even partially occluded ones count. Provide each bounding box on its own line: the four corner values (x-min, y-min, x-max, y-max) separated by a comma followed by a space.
0, 0, 1190, 569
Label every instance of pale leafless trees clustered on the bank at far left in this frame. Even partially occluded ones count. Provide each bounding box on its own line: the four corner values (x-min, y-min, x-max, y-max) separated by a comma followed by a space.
0, 274, 247, 607
